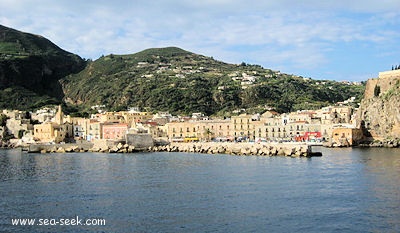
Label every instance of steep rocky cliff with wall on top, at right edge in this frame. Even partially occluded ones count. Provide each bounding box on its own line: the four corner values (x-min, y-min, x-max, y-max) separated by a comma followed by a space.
359, 70, 400, 140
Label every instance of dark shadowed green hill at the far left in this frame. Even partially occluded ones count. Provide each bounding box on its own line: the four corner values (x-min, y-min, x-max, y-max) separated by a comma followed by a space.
0, 25, 85, 109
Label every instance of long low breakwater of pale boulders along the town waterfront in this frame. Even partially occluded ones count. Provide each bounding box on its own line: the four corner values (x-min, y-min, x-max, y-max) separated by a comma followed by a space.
28, 142, 322, 157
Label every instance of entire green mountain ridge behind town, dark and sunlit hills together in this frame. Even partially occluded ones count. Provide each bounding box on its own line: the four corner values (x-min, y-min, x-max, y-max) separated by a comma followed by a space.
0, 26, 363, 115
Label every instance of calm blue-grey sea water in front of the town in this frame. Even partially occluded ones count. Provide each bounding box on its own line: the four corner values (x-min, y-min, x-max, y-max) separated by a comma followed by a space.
0, 148, 400, 232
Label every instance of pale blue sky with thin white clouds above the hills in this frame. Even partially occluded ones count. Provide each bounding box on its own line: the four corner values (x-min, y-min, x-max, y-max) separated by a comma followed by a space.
0, 0, 400, 81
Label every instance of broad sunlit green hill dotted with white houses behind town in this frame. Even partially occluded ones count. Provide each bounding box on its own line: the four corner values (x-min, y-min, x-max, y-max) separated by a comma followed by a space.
61, 47, 364, 115
